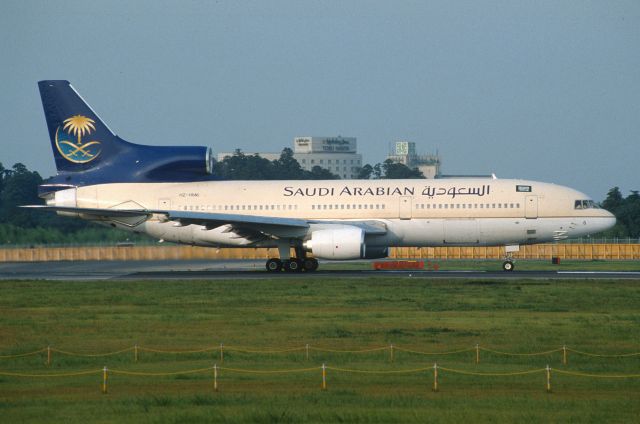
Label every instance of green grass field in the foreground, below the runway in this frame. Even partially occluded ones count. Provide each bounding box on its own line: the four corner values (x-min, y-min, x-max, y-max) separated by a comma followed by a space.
0, 276, 640, 423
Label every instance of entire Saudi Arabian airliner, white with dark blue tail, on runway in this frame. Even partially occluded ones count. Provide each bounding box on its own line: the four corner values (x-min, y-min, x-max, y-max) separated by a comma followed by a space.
26, 81, 615, 271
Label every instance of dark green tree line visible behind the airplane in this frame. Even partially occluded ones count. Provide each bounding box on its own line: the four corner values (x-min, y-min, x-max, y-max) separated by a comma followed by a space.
0, 152, 640, 245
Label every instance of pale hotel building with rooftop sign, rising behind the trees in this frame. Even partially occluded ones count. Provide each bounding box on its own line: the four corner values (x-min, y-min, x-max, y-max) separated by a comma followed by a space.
218, 136, 362, 179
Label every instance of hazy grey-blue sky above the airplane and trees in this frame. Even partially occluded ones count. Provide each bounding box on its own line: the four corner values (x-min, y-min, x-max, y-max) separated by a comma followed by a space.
0, 0, 640, 200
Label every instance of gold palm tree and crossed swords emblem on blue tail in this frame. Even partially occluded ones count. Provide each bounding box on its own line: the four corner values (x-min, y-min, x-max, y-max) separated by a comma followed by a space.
56, 115, 102, 163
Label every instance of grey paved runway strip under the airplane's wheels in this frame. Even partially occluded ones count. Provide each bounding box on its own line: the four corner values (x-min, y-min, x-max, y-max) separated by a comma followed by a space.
0, 260, 640, 281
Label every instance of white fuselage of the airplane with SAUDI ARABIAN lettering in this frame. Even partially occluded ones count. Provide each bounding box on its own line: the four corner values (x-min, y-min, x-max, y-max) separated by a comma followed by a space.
49, 178, 615, 247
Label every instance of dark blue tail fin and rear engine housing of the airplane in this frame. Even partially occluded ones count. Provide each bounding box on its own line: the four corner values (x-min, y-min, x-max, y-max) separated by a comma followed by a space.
38, 80, 214, 194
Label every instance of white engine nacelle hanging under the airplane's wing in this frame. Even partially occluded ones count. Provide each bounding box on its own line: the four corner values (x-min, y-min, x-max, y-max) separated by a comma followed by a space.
304, 225, 366, 260
